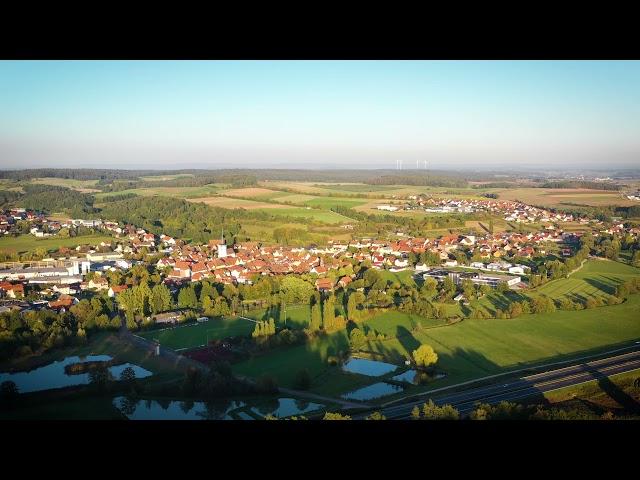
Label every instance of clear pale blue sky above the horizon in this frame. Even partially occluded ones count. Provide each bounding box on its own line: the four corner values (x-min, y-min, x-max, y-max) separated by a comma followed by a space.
0, 61, 640, 169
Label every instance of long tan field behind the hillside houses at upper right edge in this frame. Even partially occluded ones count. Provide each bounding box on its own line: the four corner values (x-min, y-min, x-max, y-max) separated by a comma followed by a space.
494, 188, 636, 207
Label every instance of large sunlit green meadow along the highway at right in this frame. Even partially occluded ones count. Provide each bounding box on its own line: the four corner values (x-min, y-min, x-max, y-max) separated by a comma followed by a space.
368, 295, 640, 381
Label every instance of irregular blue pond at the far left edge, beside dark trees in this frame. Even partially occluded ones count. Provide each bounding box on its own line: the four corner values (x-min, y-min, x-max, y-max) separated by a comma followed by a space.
0, 355, 153, 393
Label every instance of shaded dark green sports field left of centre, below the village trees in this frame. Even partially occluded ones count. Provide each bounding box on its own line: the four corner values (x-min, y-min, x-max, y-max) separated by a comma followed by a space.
138, 317, 255, 350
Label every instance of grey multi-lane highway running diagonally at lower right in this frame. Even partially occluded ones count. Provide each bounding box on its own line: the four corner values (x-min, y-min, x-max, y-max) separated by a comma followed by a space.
354, 347, 640, 420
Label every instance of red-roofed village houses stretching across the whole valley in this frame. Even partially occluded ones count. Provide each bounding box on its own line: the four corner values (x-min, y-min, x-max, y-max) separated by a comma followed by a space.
0, 200, 640, 322
